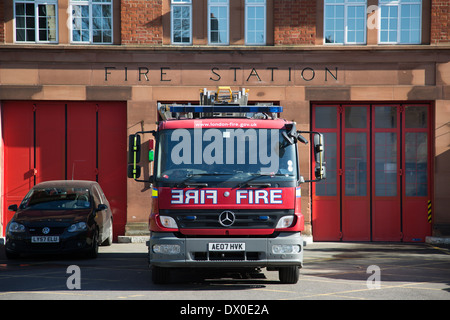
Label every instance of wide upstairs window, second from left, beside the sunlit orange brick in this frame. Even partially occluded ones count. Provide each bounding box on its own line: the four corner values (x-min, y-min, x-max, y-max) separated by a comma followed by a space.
70, 0, 113, 44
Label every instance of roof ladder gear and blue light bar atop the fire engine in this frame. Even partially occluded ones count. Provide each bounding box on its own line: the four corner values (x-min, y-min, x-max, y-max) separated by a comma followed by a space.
158, 87, 283, 120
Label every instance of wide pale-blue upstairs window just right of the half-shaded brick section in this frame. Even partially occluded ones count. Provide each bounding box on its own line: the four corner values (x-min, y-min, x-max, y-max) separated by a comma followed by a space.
324, 0, 367, 44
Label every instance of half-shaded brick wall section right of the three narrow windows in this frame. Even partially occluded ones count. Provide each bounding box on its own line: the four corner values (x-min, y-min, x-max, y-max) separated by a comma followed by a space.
273, 0, 316, 45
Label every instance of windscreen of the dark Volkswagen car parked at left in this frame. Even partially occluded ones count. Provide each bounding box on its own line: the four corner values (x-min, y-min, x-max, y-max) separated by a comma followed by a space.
20, 187, 91, 210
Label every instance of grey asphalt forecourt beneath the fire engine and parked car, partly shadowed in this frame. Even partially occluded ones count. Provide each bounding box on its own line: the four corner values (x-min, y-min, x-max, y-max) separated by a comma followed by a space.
0, 243, 450, 302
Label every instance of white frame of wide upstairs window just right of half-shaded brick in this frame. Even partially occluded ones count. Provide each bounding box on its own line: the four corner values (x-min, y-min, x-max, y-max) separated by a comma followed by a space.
323, 0, 367, 46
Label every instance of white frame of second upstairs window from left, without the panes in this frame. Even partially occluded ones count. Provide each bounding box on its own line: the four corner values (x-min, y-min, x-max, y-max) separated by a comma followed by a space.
69, 0, 114, 45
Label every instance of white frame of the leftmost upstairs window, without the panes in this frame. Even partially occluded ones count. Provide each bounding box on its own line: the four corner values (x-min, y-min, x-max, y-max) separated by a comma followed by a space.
13, 0, 59, 44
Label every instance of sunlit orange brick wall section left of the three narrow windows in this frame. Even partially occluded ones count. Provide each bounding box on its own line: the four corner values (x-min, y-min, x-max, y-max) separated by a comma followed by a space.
120, 0, 163, 44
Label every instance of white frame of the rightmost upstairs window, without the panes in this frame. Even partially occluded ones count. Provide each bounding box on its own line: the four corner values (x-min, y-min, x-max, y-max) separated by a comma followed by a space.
378, 0, 423, 45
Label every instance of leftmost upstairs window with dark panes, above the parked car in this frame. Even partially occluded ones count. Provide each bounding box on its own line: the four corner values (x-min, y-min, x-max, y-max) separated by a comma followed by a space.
14, 0, 58, 43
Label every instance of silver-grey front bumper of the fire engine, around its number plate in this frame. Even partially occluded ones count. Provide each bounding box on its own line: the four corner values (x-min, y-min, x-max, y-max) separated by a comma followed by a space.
149, 232, 303, 268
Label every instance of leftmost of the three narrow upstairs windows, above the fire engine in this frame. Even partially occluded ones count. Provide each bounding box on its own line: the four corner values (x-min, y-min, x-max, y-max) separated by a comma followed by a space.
171, 0, 192, 44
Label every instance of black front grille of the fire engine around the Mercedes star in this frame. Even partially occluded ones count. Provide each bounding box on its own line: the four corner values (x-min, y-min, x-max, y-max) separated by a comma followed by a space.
159, 209, 294, 229
